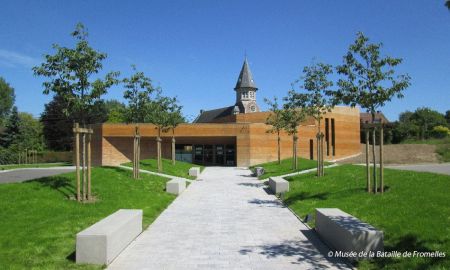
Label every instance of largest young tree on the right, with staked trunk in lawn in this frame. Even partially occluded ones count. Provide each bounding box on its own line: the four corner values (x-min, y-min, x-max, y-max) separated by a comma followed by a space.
335, 32, 410, 193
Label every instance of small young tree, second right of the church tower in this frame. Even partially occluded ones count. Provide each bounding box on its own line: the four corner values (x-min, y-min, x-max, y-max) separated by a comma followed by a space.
282, 90, 306, 170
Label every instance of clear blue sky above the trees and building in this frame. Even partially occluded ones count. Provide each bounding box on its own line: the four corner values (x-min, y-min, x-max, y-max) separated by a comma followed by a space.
0, 0, 450, 120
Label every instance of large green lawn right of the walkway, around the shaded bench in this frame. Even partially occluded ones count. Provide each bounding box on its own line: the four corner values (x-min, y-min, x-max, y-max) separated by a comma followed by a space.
284, 165, 450, 269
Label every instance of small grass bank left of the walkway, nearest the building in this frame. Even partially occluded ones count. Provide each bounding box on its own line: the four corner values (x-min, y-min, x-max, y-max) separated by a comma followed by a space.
122, 159, 204, 179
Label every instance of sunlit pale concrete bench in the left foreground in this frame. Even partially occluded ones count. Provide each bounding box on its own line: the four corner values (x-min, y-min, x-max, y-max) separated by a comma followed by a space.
76, 209, 142, 265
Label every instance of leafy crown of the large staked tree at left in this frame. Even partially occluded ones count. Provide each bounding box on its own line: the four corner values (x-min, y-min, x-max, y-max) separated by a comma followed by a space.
33, 23, 119, 124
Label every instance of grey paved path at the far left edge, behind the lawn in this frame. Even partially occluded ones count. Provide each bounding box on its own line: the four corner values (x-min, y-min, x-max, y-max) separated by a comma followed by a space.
0, 166, 75, 184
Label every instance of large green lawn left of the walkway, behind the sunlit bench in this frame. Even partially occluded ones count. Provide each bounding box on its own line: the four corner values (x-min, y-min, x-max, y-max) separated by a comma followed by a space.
0, 167, 175, 269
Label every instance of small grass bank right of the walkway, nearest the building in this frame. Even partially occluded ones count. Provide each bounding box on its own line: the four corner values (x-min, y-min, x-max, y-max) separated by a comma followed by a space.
250, 158, 328, 179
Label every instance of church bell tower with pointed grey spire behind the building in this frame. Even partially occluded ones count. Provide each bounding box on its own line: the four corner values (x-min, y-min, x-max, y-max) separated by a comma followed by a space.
234, 58, 259, 113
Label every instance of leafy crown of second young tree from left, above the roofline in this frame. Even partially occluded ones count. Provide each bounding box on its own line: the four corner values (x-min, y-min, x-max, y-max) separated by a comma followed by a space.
122, 65, 159, 123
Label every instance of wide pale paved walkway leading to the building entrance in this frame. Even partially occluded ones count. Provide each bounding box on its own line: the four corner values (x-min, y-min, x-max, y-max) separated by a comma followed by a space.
108, 167, 348, 269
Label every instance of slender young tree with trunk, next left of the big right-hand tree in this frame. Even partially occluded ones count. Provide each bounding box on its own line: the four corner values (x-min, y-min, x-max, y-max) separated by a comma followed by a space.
293, 63, 333, 177
